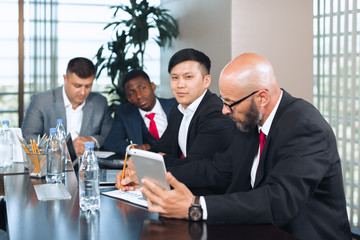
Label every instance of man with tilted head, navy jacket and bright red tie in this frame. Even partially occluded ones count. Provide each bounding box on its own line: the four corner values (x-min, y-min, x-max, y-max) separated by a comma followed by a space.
104, 69, 176, 157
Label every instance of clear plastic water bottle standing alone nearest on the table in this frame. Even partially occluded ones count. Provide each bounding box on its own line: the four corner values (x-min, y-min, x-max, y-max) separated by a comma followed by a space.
79, 142, 100, 211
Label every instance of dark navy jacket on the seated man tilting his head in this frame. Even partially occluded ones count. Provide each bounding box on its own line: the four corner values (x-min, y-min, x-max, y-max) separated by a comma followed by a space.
104, 98, 177, 156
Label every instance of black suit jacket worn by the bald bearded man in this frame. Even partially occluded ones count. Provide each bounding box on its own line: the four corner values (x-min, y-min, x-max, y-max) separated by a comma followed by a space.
170, 91, 351, 239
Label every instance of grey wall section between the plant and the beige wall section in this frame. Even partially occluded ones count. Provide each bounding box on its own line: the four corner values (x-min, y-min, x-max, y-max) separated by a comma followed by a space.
157, 0, 231, 96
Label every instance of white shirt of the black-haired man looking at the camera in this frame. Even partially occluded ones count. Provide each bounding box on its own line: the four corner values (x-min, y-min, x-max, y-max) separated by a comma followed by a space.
178, 90, 206, 157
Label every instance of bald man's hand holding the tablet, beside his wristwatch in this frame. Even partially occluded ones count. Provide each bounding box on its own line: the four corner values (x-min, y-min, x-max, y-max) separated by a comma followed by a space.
141, 172, 194, 218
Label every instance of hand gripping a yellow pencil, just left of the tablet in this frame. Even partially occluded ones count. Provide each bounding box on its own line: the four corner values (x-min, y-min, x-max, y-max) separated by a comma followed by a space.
115, 157, 140, 191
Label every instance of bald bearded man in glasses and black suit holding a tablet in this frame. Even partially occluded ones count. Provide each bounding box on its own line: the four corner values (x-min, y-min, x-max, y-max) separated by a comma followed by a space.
142, 54, 351, 239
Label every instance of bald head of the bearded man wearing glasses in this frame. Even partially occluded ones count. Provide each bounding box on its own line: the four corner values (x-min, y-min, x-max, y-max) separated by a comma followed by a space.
219, 53, 281, 125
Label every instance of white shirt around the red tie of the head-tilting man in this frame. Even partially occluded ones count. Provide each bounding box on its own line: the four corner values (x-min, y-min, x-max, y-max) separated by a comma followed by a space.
139, 98, 167, 137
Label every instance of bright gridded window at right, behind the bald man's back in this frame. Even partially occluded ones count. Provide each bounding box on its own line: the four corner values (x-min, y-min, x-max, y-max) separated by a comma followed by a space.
314, 0, 360, 232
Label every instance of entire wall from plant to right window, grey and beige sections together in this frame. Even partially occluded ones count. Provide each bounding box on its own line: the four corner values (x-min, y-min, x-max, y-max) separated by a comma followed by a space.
157, 0, 313, 102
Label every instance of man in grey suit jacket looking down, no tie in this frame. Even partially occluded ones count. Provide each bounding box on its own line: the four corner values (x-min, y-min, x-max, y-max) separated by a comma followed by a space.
21, 57, 112, 155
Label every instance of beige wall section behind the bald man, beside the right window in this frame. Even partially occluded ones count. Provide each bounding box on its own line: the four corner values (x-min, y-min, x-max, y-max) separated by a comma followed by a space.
231, 0, 313, 102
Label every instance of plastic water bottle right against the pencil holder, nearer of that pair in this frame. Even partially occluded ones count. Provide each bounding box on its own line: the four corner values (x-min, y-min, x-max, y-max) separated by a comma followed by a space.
46, 128, 64, 183
